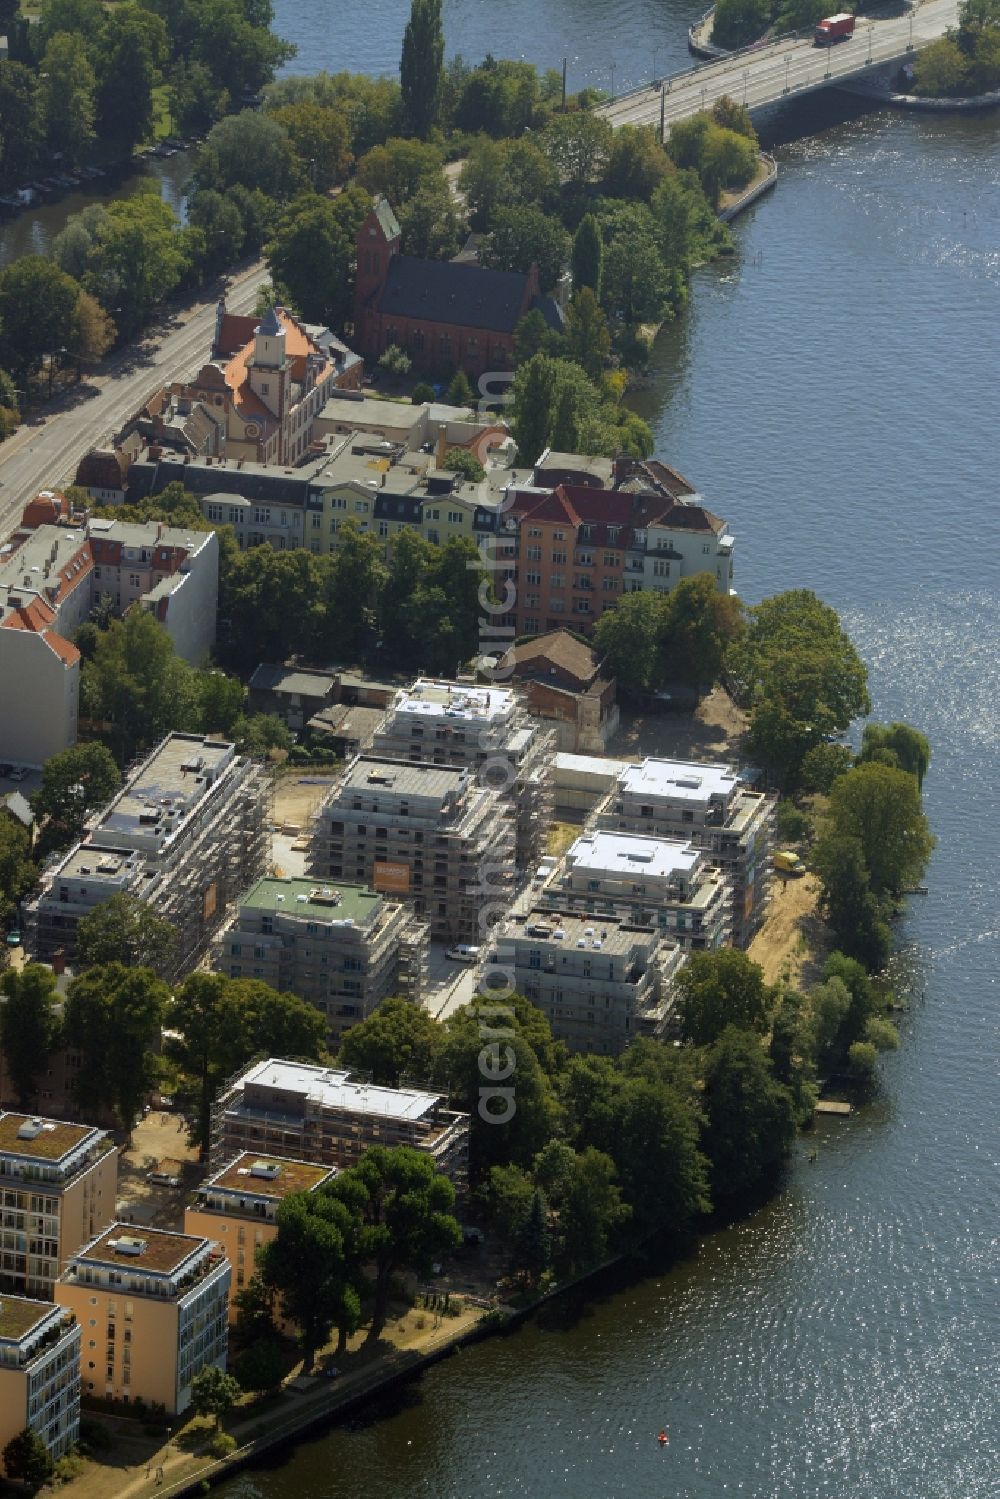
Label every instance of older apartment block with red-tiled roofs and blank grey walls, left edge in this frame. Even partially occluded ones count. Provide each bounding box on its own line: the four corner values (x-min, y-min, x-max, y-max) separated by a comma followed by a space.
0, 515, 219, 766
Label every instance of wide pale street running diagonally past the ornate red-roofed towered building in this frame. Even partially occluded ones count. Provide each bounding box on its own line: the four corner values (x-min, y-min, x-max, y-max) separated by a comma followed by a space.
0, 261, 267, 537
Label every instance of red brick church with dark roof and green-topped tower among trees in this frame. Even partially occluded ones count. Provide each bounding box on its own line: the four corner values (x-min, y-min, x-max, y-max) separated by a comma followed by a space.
352, 198, 562, 378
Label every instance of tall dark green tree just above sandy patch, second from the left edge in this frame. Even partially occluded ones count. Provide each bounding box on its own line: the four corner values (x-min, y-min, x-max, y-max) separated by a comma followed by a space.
63, 965, 169, 1136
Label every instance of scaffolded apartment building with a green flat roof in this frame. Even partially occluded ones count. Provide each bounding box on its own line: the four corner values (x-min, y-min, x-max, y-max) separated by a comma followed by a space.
213, 877, 427, 1049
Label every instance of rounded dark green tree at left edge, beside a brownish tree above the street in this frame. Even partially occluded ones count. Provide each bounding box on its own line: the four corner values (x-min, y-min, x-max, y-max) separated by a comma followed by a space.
0, 255, 79, 379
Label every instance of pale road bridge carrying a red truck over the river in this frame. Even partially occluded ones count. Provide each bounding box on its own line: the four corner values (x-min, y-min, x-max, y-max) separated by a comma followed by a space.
600, 0, 958, 135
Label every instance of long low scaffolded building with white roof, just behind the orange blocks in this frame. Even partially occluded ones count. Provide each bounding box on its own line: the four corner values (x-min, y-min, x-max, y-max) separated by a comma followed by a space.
211, 1057, 469, 1190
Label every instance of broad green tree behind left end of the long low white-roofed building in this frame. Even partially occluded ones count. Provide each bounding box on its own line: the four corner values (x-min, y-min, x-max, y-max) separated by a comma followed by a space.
165, 973, 327, 1150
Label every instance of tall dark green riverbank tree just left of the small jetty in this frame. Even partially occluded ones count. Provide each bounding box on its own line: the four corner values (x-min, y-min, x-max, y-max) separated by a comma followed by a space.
703, 1025, 795, 1205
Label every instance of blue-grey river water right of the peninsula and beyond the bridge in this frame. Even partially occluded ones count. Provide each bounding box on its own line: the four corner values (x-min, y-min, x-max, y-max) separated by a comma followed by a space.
215, 0, 1000, 1499
